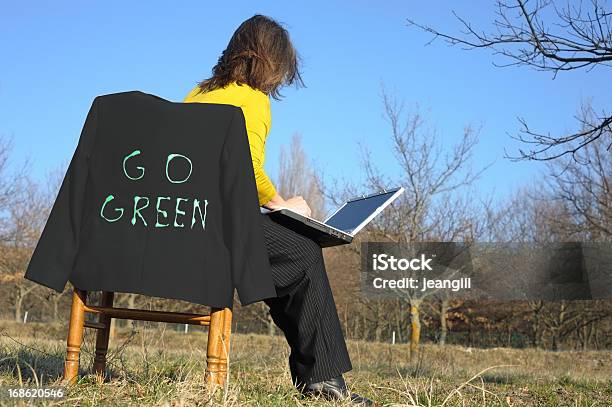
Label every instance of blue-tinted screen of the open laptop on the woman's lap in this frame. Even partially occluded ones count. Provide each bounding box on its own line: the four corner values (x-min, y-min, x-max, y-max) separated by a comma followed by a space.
325, 189, 397, 234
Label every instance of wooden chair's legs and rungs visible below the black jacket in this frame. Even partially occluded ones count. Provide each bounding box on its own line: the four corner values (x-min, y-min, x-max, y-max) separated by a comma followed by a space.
64, 288, 232, 390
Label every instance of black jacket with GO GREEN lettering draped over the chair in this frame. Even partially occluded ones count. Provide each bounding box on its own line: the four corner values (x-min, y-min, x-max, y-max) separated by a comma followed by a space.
25, 91, 276, 307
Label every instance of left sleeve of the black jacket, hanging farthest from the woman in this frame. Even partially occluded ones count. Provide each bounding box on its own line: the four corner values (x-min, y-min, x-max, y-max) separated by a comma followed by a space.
25, 98, 99, 292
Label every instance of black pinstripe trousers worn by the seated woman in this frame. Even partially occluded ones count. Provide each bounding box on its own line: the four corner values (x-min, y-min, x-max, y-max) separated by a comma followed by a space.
262, 215, 352, 387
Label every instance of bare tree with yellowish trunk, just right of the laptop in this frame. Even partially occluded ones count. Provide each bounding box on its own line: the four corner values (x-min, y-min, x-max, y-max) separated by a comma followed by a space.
362, 88, 486, 360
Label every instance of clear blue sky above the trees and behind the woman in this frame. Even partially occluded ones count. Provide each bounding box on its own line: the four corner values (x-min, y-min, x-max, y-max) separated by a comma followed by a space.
0, 0, 612, 204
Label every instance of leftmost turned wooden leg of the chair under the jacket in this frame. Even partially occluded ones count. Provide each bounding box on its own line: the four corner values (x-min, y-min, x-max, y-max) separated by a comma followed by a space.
64, 287, 87, 384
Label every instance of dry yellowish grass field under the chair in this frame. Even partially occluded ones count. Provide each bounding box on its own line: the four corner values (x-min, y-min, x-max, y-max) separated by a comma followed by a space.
0, 322, 612, 407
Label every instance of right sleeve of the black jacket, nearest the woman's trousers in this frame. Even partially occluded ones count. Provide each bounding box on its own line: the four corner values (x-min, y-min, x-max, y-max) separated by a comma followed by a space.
221, 107, 276, 305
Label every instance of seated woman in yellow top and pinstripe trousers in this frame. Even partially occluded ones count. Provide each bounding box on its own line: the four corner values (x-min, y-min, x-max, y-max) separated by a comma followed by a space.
184, 15, 371, 404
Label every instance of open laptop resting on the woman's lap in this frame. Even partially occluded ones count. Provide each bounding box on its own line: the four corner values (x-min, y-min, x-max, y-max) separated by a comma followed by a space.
265, 187, 404, 247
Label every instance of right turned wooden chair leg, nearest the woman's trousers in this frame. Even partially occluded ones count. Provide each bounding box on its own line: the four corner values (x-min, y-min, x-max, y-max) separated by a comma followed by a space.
206, 308, 232, 389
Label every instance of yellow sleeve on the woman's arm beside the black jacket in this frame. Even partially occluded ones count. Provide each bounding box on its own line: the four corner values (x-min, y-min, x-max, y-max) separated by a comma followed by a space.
242, 97, 276, 205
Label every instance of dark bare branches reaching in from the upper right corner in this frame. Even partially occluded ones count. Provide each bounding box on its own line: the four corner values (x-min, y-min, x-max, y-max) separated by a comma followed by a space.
408, 0, 612, 160
